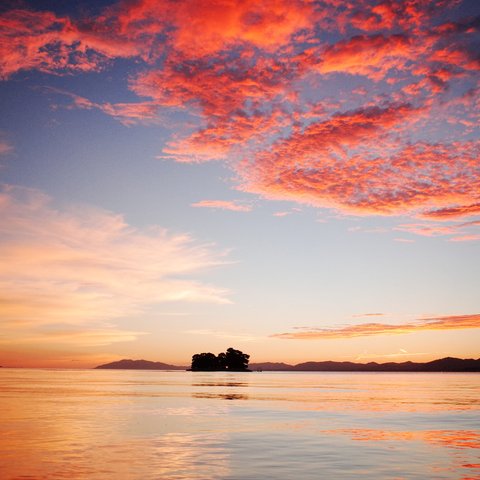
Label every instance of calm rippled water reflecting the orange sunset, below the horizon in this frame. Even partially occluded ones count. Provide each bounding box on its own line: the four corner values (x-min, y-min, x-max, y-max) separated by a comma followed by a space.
0, 368, 480, 480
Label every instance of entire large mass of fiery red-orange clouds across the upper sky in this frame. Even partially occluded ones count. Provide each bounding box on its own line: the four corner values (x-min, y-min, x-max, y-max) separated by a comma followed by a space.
0, 0, 480, 223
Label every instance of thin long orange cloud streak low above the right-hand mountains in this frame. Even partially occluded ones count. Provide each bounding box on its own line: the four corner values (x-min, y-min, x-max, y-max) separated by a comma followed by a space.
272, 314, 480, 340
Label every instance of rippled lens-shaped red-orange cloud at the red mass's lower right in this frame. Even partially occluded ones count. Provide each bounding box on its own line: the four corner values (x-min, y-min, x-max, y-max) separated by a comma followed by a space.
238, 127, 480, 215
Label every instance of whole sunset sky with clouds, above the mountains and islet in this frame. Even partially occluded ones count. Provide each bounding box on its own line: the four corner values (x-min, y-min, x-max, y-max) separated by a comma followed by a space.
0, 0, 480, 368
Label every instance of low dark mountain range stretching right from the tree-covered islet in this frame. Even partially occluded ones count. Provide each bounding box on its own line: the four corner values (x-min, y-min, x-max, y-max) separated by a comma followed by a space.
250, 357, 480, 372
